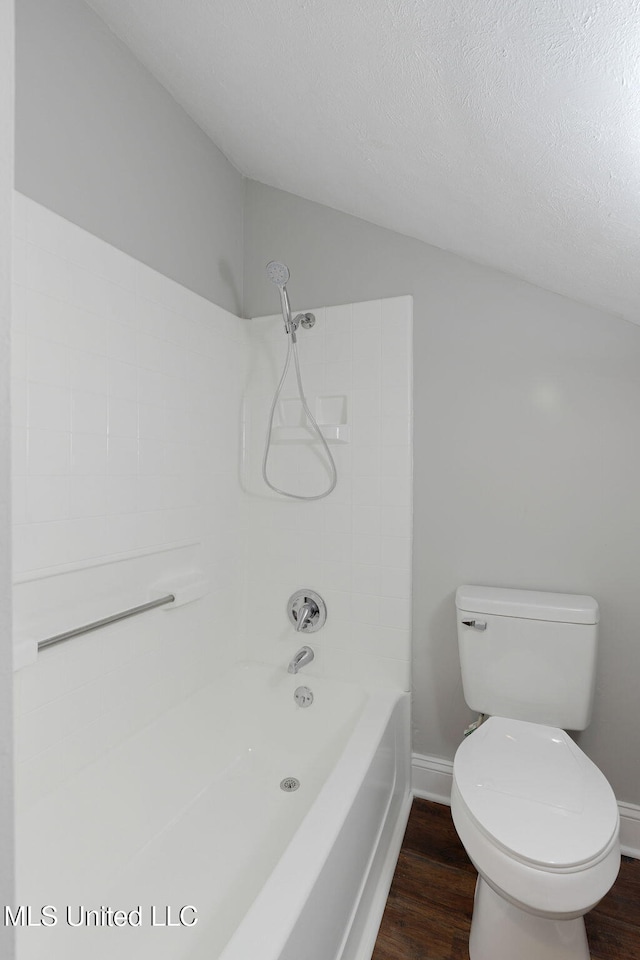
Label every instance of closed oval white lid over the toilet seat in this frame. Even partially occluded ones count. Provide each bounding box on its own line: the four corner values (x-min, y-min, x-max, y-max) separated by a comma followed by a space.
453, 717, 619, 868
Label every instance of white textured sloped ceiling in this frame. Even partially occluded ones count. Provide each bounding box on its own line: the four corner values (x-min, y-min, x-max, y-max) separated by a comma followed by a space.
89, 0, 640, 323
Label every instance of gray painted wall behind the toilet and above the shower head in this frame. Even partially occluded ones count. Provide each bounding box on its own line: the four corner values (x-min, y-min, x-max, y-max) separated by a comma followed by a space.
244, 182, 640, 803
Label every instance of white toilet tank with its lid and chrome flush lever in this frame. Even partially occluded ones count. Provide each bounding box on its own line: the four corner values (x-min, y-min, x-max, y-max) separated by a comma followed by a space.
456, 586, 599, 730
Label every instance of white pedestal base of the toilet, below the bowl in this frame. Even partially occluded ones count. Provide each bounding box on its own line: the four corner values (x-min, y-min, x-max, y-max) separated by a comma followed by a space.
469, 876, 589, 960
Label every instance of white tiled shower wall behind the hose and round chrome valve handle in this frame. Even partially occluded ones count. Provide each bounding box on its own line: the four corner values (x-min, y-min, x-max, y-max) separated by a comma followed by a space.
244, 297, 413, 689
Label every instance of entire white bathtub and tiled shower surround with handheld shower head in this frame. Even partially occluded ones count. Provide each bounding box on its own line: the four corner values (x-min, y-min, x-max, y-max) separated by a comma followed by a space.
15, 201, 411, 960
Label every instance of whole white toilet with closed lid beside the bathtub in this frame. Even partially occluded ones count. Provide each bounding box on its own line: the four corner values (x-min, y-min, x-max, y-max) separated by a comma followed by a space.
451, 586, 620, 960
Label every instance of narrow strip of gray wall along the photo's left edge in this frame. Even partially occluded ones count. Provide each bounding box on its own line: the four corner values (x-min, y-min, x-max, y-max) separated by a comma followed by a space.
0, 0, 15, 948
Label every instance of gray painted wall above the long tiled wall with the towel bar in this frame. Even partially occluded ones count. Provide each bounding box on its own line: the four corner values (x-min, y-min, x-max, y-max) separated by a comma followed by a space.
16, 0, 243, 313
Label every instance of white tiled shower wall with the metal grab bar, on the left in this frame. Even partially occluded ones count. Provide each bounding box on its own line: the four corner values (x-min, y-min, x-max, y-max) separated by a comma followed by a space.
12, 194, 247, 803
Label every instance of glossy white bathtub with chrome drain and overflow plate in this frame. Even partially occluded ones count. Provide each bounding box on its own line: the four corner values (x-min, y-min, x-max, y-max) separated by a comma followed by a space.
18, 664, 410, 960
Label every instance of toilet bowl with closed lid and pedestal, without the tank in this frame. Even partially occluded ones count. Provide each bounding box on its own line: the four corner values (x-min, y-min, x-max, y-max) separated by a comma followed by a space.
451, 717, 620, 960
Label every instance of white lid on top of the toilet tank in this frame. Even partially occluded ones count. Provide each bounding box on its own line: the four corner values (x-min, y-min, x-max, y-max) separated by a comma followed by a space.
456, 586, 600, 623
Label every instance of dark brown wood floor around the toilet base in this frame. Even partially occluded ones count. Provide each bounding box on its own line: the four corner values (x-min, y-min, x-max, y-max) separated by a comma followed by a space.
372, 800, 640, 960
